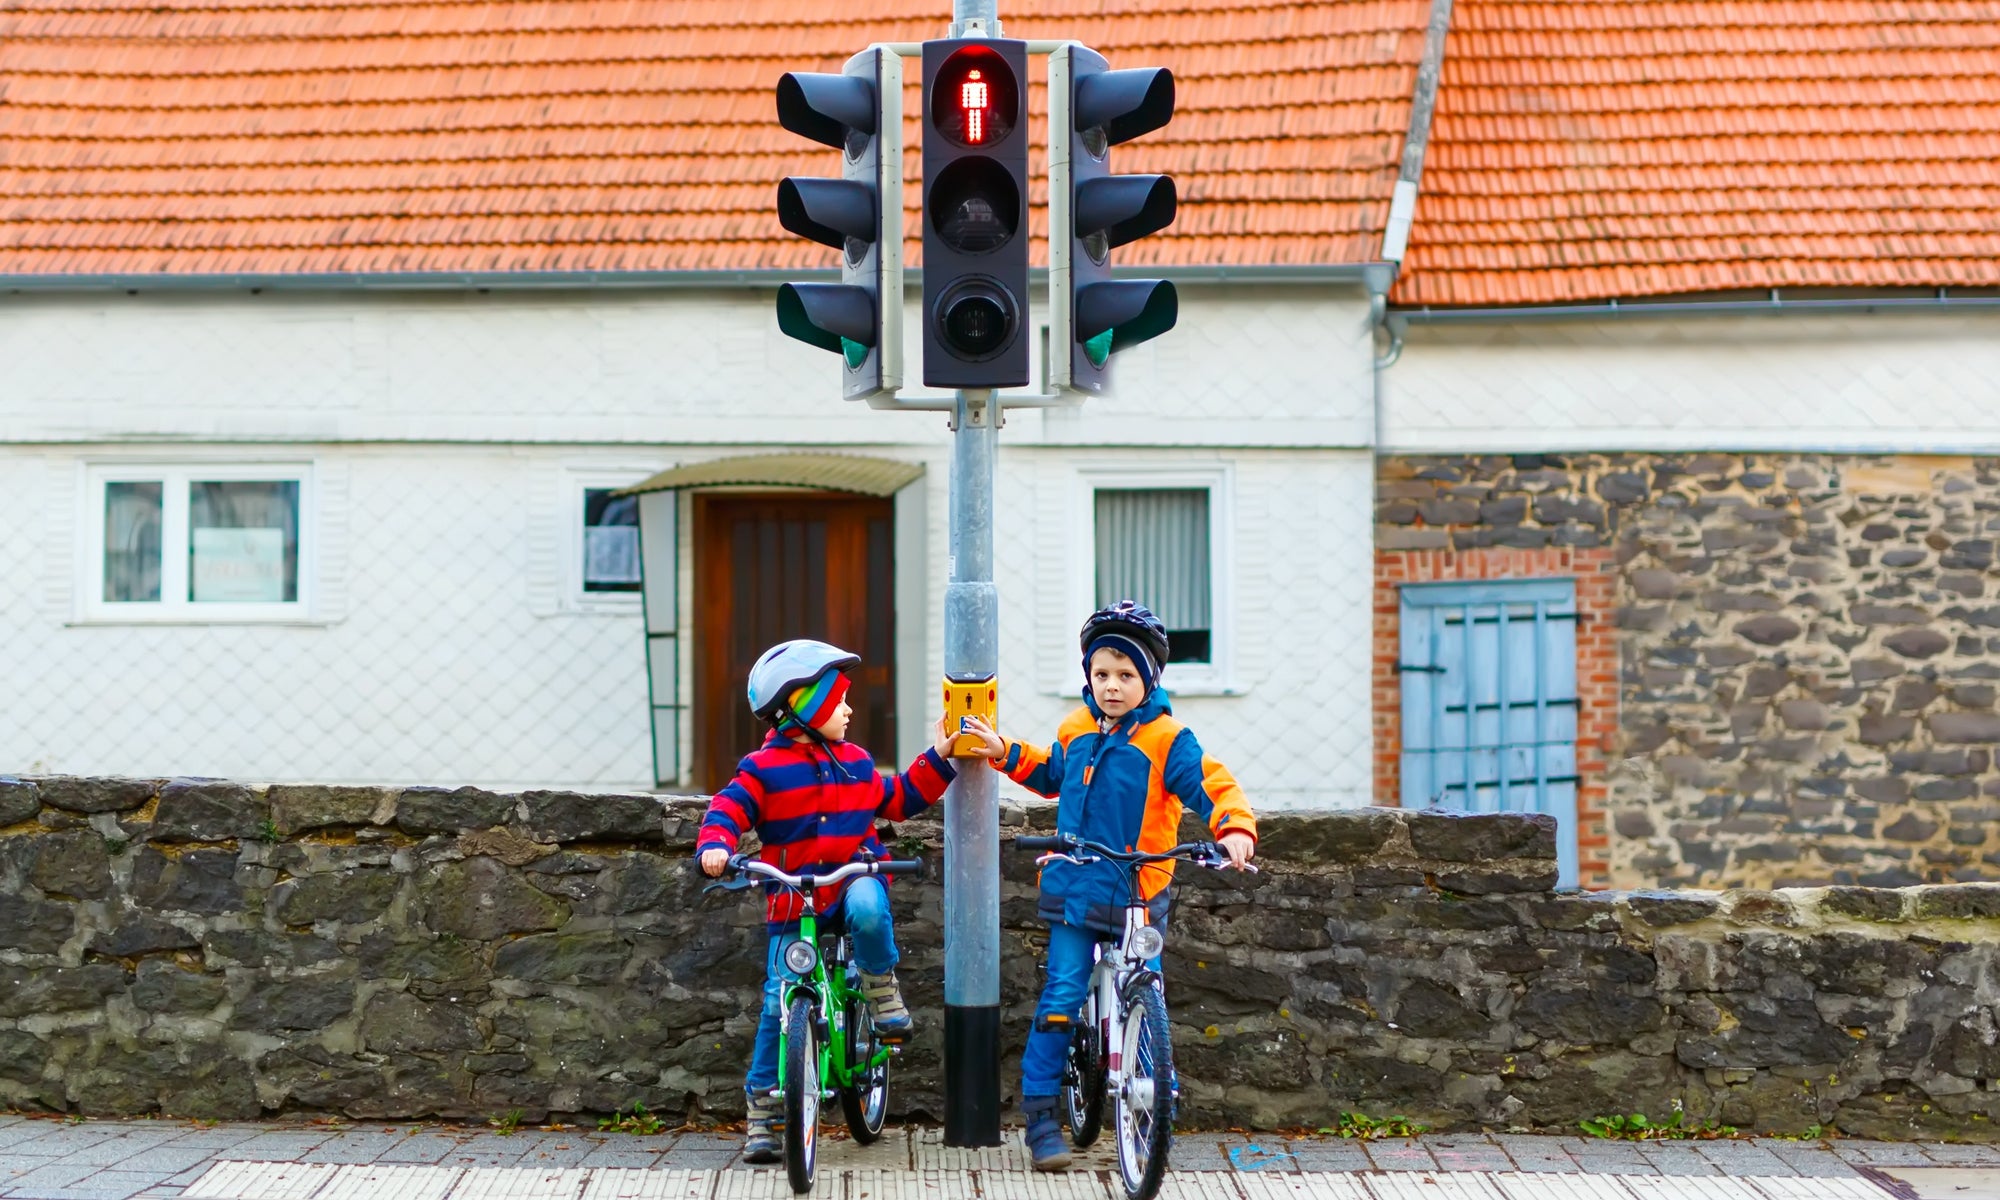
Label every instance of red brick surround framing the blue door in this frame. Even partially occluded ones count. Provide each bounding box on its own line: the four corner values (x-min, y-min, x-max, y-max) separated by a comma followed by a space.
1374, 546, 1618, 888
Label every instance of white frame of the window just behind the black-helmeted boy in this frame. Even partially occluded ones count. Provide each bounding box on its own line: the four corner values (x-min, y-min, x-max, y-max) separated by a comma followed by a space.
1064, 462, 1244, 696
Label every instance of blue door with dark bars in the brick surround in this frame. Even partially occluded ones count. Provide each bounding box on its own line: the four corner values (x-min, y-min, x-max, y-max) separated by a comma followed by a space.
1398, 580, 1576, 888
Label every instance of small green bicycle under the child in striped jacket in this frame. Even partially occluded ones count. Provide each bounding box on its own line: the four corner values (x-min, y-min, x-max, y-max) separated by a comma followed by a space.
702, 854, 924, 1192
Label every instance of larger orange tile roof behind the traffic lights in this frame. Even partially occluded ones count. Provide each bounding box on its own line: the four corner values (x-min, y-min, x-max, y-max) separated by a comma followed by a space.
0, 0, 1428, 274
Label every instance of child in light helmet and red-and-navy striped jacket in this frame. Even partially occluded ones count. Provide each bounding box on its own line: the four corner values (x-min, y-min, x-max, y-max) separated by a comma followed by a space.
694, 640, 988, 1162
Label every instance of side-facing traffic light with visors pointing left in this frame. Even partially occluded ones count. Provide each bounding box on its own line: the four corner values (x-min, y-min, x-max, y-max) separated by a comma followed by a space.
778, 48, 902, 400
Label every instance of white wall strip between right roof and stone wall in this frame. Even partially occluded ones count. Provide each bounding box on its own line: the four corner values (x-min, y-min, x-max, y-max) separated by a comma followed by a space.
1380, 312, 2000, 454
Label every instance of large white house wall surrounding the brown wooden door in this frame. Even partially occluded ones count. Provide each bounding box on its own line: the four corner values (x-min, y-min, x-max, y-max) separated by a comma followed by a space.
0, 286, 1374, 806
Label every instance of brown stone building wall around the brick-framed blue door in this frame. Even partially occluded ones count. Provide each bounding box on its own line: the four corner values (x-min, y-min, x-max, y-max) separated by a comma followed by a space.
1376, 454, 2000, 888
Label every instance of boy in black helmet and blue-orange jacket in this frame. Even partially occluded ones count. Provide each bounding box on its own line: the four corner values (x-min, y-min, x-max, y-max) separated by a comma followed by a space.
966, 600, 1256, 1170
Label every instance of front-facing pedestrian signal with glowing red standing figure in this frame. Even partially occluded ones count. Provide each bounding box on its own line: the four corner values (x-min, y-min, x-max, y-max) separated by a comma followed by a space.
922, 38, 1030, 388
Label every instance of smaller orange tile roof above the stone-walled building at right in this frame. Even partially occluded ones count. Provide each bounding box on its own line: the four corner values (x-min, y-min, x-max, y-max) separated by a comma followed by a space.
1392, 0, 2000, 304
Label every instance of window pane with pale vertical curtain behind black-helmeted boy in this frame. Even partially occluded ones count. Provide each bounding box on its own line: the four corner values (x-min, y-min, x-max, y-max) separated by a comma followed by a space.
1096, 488, 1214, 662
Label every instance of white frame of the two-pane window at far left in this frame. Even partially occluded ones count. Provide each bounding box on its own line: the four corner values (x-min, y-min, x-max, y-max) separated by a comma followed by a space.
76, 458, 320, 624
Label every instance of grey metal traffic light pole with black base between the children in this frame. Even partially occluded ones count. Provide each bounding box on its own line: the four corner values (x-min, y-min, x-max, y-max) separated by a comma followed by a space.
944, 392, 1000, 1146
